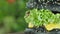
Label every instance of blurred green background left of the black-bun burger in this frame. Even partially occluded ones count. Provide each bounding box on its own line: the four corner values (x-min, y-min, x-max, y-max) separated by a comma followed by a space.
0, 0, 28, 34
